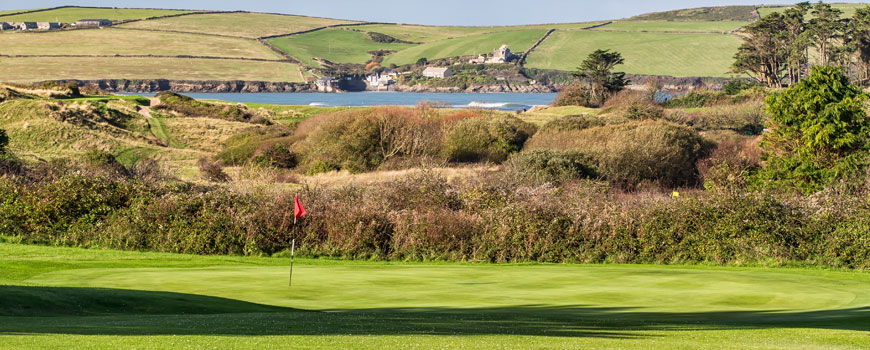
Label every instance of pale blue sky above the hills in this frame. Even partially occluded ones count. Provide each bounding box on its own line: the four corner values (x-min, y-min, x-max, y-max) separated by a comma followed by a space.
0, 0, 868, 25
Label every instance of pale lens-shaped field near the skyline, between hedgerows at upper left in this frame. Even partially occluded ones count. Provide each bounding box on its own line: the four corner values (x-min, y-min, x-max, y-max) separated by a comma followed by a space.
123, 13, 354, 38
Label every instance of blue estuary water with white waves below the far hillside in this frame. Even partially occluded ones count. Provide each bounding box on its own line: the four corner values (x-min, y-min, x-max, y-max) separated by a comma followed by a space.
130, 92, 556, 111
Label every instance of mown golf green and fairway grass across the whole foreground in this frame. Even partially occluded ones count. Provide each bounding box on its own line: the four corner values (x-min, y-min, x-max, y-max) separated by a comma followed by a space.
0, 244, 870, 349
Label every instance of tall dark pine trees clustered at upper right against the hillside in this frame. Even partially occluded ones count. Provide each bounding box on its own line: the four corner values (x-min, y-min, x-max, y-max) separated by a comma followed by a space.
732, 2, 870, 88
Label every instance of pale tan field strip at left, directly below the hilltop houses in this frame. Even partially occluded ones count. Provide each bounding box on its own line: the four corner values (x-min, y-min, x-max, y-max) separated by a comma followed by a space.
0, 29, 282, 59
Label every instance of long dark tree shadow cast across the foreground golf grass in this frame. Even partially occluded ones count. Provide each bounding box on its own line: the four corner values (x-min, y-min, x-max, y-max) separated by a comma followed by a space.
0, 286, 870, 339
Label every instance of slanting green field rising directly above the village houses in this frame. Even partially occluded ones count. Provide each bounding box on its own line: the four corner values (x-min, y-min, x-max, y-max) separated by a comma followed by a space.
384, 30, 546, 65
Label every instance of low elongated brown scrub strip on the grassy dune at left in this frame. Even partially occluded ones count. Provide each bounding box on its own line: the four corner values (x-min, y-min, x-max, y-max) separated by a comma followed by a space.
153, 91, 271, 125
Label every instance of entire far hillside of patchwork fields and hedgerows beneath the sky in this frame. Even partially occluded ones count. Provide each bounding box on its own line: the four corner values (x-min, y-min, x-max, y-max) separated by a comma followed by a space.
0, 4, 865, 83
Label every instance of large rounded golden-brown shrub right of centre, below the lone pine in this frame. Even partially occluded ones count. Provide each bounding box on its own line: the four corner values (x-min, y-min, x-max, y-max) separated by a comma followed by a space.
527, 121, 712, 188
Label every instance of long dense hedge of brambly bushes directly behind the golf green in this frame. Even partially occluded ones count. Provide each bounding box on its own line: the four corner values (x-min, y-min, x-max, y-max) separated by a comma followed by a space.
0, 160, 870, 269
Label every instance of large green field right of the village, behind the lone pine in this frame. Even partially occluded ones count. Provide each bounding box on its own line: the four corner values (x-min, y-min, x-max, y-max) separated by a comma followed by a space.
524, 31, 740, 77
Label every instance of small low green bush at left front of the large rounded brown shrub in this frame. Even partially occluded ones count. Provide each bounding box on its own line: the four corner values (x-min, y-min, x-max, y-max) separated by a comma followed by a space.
504, 150, 597, 186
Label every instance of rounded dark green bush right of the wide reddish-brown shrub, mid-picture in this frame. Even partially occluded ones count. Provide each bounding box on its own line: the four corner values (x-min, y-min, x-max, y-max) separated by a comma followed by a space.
444, 116, 536, 163
